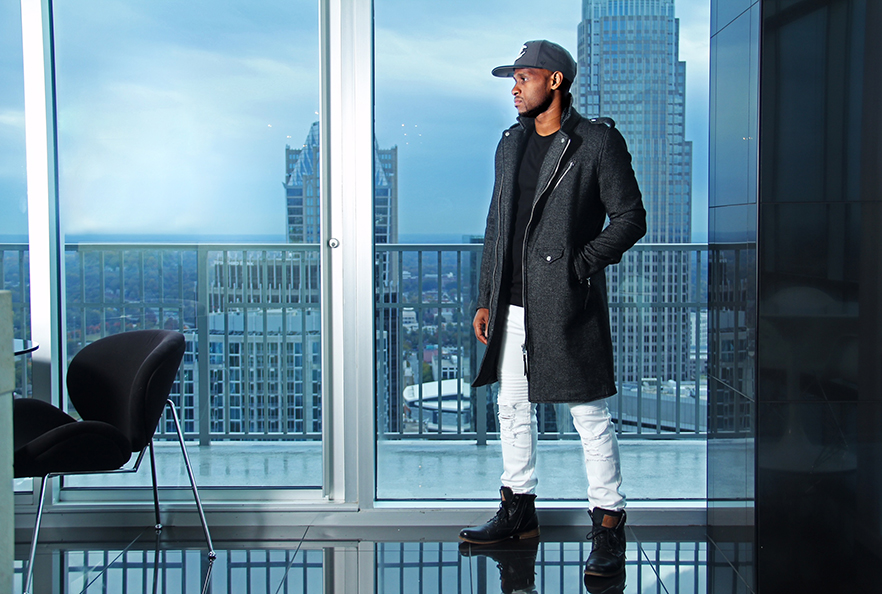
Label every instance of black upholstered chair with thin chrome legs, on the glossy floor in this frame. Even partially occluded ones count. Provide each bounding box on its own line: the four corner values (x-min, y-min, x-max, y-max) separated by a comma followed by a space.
13, 330, 215, 592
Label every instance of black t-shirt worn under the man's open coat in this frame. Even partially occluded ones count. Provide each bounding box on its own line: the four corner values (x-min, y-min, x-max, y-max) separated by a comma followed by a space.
508, 130, 554, 307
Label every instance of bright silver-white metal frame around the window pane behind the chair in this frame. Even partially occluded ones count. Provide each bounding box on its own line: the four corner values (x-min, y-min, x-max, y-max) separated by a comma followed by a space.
16, 0, 374, 512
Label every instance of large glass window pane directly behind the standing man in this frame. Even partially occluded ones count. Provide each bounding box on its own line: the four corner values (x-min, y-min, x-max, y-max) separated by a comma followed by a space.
374, 0, 709, 500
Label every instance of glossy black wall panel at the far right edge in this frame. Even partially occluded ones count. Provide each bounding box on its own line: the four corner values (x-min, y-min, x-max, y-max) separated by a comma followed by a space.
756, 0, 882, 593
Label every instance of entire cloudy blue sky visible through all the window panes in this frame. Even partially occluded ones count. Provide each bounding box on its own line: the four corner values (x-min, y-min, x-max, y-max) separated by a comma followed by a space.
0, 0, 710, 241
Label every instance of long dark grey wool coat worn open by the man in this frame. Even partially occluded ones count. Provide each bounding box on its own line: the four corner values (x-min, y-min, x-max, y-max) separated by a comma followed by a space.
473, 99, 646, 402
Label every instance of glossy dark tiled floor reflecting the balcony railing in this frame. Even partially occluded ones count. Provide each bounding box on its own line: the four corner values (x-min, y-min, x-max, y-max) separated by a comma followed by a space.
14, 527, 752, 594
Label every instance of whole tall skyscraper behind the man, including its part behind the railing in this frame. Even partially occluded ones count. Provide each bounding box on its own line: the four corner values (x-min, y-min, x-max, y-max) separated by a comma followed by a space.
573, 0, 695, 382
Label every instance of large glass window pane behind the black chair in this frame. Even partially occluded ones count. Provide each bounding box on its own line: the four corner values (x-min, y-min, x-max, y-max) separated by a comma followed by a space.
54, 0, 322, 487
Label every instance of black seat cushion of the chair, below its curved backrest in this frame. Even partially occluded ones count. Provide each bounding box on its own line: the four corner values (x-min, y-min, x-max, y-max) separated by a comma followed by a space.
13, 399, 132, 478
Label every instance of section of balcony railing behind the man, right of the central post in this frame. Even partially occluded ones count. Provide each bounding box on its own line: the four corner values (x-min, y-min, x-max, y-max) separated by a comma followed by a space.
375, 244, 708, 443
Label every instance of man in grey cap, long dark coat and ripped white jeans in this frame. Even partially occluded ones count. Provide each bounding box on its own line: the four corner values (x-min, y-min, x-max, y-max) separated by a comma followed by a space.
460, 41, 646, 576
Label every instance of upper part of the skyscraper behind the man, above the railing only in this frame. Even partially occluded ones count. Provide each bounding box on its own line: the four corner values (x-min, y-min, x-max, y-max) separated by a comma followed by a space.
575, 0, 692, 243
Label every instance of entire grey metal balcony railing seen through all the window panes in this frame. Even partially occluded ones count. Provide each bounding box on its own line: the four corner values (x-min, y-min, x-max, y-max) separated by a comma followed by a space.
2, 243, 708, 444
